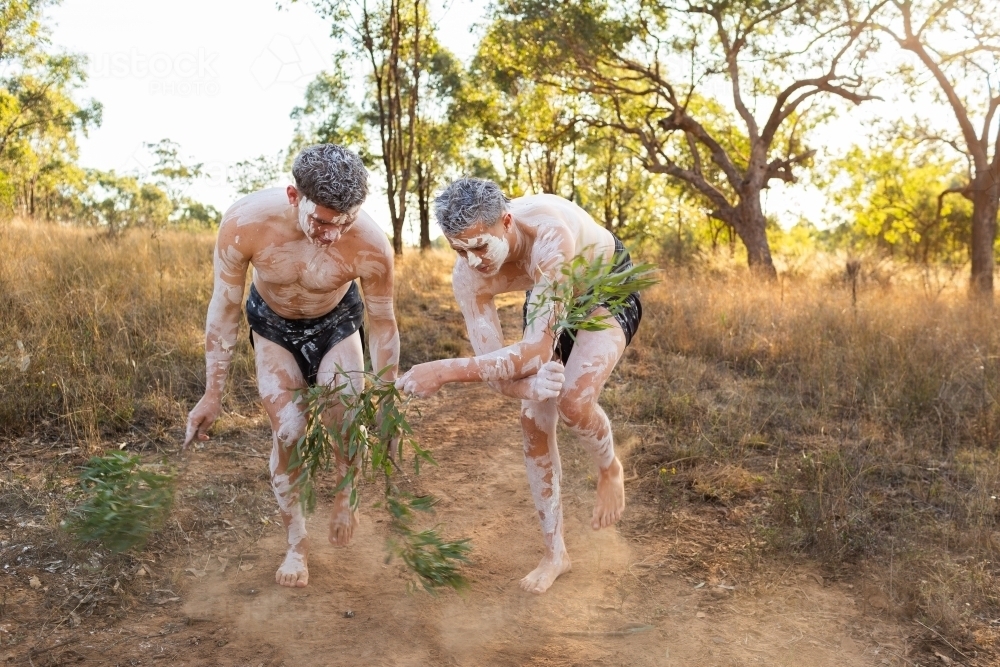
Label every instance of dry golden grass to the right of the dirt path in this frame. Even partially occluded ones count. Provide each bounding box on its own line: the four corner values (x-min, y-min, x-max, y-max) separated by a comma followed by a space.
605, 260, 1000, 648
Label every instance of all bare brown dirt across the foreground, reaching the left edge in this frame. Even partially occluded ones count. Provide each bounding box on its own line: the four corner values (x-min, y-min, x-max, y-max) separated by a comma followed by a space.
0, 386, 932, 667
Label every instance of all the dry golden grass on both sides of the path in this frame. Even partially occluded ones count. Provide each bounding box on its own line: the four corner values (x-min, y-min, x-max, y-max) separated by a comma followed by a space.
0, 223, 1000, 656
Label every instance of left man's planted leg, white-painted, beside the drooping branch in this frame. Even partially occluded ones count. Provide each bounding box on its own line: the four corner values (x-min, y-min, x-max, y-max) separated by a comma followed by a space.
254, 336, 309, 588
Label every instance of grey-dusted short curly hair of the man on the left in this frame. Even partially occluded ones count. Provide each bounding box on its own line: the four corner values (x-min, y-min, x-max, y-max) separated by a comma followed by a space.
292, 144, 368, 213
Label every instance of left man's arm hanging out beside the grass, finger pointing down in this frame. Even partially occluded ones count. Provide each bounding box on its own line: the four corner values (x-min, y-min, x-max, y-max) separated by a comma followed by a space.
183, 220, 250, 448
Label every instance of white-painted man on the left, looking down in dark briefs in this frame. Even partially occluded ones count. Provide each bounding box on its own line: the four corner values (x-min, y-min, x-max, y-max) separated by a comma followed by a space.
184, 144, 399, 587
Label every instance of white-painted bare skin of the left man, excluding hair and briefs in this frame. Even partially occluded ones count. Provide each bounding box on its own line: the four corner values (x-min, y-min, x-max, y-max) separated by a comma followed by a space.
185, 188, 399, 587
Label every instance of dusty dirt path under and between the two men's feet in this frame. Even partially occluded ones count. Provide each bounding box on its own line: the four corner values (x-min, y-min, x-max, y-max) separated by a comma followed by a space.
119, 386, 905, 666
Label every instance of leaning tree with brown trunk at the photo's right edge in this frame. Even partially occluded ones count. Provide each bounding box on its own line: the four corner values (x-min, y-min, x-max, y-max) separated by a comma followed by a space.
873, 0, 1000, 296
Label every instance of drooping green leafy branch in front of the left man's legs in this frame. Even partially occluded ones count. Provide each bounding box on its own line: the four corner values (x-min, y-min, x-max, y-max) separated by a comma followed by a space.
288, 368, 471, 592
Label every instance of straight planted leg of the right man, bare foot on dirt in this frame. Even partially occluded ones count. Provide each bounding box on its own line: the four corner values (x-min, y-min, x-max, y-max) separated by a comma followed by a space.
521, 399, 571, 593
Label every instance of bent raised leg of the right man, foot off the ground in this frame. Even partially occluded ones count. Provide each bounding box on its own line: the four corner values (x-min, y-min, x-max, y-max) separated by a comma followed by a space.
556, 311, 625, 530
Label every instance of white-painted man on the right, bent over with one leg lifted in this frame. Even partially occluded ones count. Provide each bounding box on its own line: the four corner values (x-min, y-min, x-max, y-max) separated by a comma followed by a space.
396, 178, 642, 593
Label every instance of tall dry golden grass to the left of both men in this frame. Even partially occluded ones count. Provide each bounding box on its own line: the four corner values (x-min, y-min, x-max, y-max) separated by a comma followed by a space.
0, 222, 258, 444
